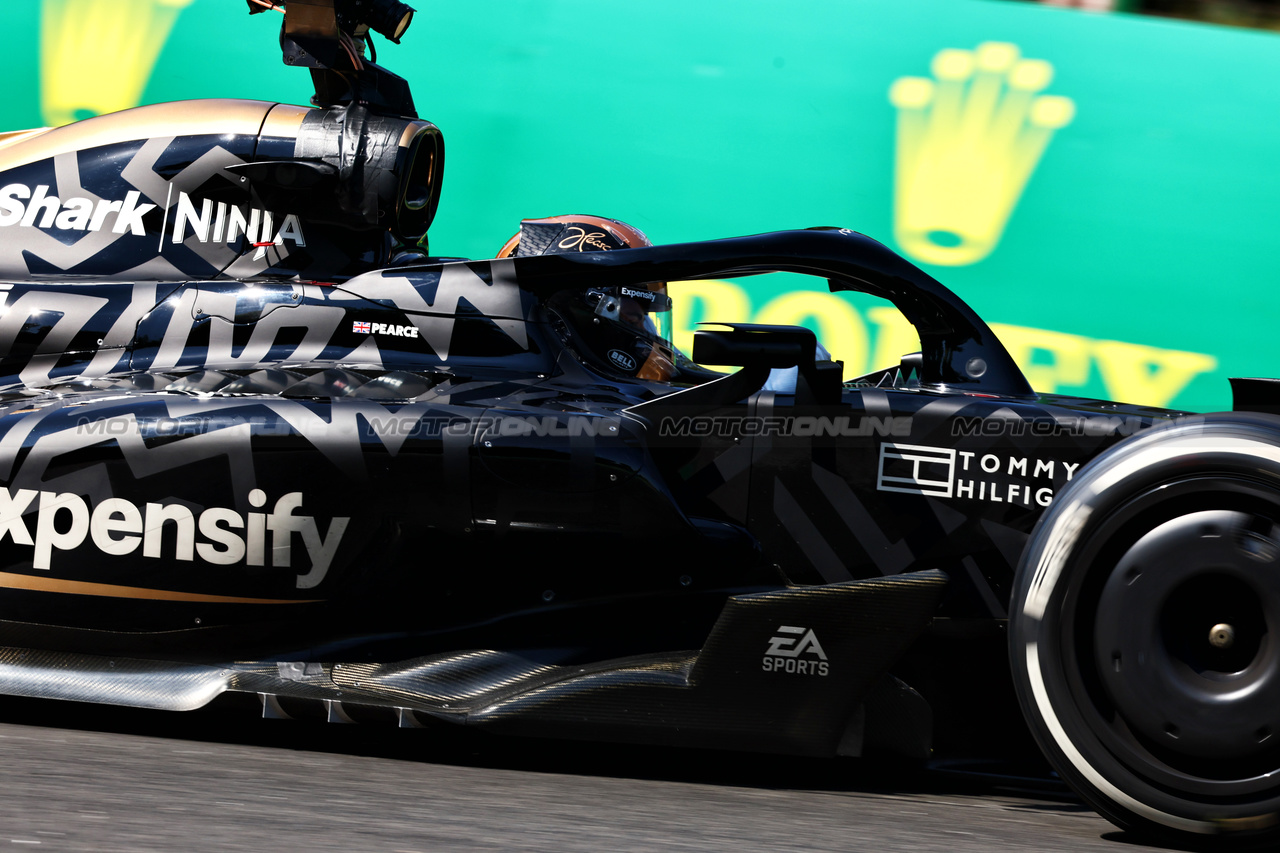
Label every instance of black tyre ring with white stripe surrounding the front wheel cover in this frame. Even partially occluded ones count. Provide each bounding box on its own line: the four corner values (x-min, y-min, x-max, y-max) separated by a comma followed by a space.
1010, 412, 1280, 840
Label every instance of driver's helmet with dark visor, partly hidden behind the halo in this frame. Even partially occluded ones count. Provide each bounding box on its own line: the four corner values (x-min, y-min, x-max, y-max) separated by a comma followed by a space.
498, 214, 682, 382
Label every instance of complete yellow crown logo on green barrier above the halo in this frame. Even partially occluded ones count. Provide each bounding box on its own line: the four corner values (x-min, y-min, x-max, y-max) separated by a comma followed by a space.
888, 41, 1075, 266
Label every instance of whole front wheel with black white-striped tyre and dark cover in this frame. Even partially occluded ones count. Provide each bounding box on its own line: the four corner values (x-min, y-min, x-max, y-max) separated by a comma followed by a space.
1010, 412, 1280, 847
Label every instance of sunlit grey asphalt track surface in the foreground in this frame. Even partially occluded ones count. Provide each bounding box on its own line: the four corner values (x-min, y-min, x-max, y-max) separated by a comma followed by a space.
0, 698, 1177, 853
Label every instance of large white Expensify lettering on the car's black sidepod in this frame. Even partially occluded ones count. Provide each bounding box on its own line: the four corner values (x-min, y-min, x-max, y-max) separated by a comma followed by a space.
0, 487, 351, 589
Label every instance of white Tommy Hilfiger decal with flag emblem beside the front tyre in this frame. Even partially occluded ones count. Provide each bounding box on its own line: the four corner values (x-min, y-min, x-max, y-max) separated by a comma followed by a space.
876, 443, 1080, 507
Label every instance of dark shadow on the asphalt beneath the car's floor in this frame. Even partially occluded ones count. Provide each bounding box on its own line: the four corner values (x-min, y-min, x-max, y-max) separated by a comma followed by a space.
0, 694, 1075, 812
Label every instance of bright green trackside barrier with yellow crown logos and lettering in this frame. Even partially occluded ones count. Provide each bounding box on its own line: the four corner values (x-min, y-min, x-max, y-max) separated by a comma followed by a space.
0, 0, 1280, 410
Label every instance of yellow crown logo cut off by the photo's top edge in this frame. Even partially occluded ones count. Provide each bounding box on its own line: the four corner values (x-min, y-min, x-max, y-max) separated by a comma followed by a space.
40, 0, 192, 126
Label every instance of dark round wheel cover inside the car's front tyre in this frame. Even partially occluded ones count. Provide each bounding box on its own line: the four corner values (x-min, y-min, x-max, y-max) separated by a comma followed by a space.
1062, 476, 1280, 802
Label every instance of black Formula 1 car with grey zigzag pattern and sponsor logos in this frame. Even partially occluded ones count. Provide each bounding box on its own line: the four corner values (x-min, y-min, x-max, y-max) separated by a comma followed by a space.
0, 0, 1280, 844
